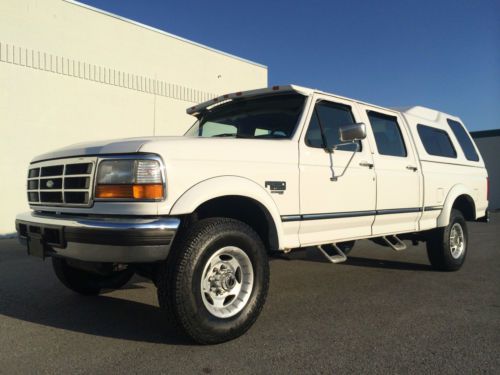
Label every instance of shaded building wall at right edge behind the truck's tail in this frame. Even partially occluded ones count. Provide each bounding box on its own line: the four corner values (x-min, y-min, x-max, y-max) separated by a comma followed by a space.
471, 135, 500, 210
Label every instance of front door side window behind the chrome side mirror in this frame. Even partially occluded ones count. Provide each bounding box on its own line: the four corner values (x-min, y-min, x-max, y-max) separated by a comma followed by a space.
306, 101, 361, 151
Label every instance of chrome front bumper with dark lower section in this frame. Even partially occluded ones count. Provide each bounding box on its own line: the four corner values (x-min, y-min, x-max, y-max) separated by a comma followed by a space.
16, 212, 180, 263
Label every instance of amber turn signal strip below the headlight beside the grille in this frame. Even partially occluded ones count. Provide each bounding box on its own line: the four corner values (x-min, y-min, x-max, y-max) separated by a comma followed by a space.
95, 184, 163, 199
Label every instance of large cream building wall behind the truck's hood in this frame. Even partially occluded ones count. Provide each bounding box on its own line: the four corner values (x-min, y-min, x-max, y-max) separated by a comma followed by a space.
0, 0, 267, 234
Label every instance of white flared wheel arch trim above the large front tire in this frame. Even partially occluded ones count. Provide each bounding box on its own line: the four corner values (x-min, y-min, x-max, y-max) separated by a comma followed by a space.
169, 176, 284, 248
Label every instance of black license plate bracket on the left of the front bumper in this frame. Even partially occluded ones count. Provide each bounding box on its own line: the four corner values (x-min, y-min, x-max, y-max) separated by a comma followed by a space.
18, 222, 65, 258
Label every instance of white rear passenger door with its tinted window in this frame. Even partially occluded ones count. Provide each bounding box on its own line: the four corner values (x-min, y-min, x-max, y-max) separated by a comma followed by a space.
362, 105, 422, 235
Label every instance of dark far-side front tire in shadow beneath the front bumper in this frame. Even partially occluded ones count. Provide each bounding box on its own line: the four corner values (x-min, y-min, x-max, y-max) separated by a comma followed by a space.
52, 257, 134, 296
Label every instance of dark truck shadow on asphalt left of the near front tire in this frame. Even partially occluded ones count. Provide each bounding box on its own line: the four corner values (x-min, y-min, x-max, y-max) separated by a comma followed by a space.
0, 280, 194, 345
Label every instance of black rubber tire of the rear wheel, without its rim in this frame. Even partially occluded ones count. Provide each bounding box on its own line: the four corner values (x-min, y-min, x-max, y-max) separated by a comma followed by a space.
427, 209, 469, 271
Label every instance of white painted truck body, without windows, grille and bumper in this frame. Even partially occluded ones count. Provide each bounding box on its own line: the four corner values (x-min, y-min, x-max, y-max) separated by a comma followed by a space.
20, 86, 488, 249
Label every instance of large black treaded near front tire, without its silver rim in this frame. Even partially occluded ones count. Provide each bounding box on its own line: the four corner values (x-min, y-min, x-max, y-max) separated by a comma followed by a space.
157, 218, 269, 344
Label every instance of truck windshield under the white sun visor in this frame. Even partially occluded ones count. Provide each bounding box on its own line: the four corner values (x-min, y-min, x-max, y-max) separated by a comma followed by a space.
185, 93, 306, 139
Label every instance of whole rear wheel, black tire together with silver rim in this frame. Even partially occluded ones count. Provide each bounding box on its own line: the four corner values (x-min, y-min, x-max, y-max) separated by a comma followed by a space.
427, 209, 469, 271
